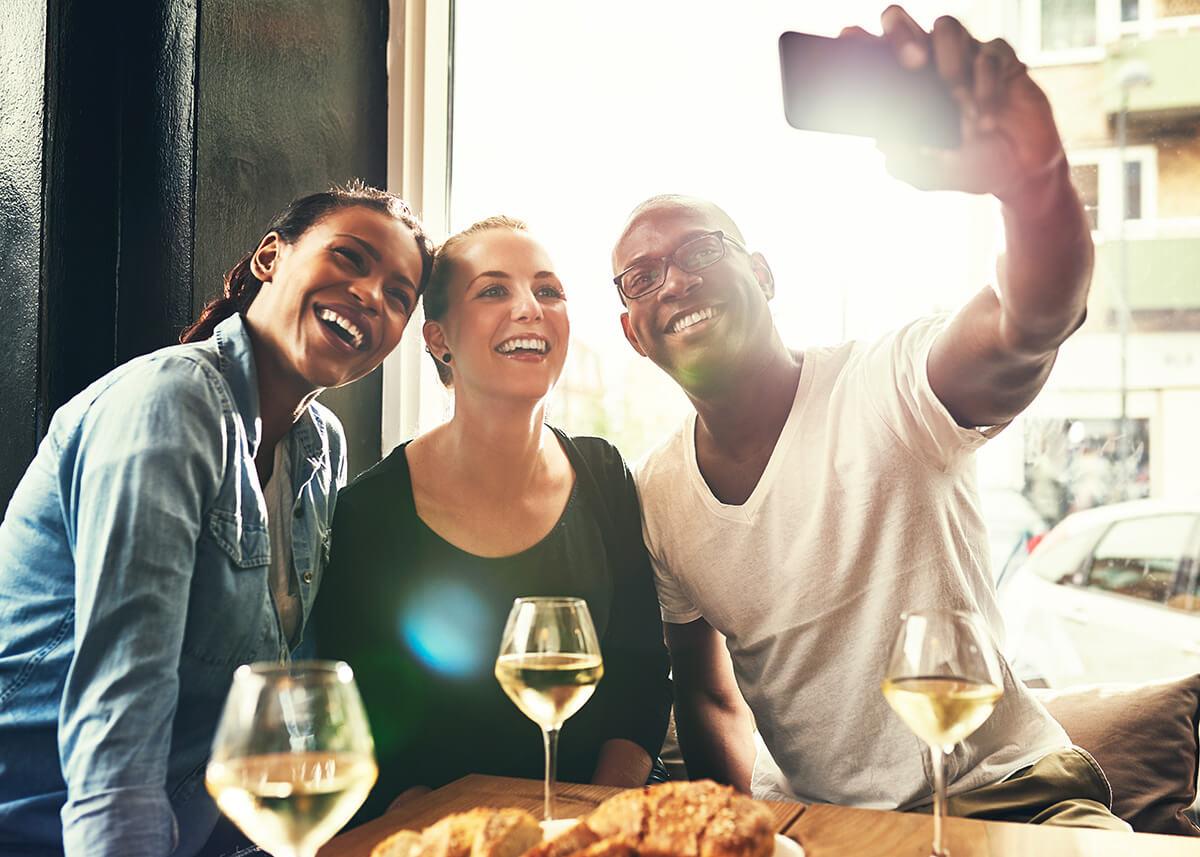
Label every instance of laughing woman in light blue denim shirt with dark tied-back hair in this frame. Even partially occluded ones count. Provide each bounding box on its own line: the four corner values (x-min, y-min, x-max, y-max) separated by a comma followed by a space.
0, 180, 432, 857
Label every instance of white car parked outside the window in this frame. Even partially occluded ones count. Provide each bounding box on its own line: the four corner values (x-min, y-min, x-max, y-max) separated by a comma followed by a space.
998, 501, 1200, 687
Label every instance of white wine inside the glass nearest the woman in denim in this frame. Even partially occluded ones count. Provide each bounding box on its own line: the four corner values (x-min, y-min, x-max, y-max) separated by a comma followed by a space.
205, 753, 378, 855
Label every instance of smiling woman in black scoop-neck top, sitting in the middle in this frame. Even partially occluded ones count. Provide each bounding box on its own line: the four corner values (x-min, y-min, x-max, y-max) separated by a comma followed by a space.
316, 217, 671, 815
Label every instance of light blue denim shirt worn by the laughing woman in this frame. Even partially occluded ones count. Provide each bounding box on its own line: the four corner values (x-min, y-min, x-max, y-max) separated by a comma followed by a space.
0, 316, 346, 857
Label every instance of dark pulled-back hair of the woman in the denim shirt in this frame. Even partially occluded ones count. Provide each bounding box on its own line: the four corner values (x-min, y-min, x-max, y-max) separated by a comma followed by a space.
179, 179, 433, 342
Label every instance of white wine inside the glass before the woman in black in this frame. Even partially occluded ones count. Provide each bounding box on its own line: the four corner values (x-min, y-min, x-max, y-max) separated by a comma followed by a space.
496, 653, 604, 730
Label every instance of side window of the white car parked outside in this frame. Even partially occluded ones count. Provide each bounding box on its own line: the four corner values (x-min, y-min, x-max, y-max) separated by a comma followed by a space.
1087, 515, 1196, 604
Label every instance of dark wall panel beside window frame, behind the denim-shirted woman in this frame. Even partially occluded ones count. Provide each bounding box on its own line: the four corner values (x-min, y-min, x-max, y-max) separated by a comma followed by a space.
193, 0, 388, 477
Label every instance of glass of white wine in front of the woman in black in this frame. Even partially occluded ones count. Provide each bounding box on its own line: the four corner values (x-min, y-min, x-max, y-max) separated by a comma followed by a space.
496, 598, 604, 821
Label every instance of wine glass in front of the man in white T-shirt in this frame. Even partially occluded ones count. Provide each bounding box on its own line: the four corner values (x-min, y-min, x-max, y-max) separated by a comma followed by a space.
882, 610, 1004, 857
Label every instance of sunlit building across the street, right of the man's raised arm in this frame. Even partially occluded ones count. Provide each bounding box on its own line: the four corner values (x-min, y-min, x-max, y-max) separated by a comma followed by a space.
1007, 0, 1200, 519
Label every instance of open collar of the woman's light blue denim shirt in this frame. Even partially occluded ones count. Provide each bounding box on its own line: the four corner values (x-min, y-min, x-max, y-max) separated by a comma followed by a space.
212, 312, 328, 489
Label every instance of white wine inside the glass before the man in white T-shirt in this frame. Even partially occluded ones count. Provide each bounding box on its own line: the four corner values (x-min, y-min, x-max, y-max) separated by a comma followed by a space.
883, 676, 1004, 748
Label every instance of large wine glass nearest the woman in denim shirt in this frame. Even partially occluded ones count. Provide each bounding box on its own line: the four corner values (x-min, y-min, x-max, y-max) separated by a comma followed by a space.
205, 661, 377, 857
